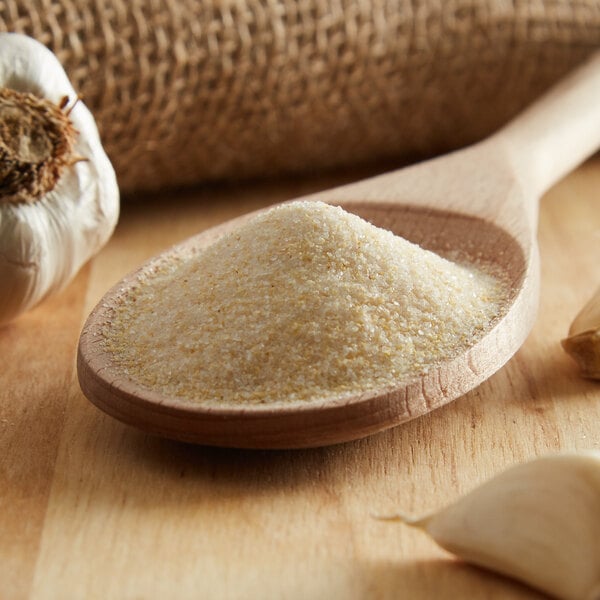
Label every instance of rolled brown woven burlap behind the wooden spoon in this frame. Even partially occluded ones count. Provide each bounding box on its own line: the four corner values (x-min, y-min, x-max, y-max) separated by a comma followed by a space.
0, 0, 600, 191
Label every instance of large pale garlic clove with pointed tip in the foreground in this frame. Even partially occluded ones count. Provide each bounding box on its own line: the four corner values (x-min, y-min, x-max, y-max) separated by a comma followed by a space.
386, 451, 600, 600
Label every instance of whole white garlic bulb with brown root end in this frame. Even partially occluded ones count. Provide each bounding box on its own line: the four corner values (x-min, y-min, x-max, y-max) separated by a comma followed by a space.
0, 33, 119, 324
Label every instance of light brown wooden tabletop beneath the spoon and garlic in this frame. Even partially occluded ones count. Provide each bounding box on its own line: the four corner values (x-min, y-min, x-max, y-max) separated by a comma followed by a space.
0, 158, 600, 600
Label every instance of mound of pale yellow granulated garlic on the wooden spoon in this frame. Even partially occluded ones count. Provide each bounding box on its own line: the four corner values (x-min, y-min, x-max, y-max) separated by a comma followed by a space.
103, 201, 504, 406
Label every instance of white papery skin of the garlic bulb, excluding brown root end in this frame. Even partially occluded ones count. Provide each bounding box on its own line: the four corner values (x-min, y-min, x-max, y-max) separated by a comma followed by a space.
0, 33, 119, 324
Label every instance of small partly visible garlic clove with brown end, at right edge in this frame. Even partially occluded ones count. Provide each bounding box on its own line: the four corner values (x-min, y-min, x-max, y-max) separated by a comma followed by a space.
561, 288, 600, 379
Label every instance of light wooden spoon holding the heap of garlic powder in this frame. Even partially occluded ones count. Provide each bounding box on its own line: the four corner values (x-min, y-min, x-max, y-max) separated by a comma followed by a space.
77, 54, 600, 448
